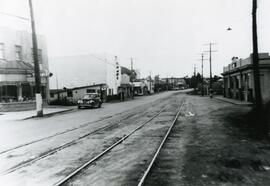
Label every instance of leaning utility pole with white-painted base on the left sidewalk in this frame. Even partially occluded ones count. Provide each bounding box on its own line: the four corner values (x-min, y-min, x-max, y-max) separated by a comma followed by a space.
29, 0, 43, 117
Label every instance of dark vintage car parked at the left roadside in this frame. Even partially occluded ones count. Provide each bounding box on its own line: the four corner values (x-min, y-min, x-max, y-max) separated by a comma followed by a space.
77, 93, 102, 109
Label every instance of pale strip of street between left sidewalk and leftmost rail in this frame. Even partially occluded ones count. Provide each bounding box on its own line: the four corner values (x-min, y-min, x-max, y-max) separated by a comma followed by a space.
0, 92, 173, 152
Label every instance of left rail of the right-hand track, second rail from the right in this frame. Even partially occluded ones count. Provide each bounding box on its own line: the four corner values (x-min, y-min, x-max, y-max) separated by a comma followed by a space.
53, 106, 168, 186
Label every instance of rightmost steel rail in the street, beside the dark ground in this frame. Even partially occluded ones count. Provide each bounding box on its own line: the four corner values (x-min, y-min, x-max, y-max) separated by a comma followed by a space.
138, 103, 184, 186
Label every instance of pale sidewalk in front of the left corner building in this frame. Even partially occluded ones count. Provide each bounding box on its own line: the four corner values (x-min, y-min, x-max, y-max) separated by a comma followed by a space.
0, 106, 77, 121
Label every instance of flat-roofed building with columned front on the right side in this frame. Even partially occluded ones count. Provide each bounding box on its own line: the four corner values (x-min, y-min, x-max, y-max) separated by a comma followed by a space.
222, 53, 270, 102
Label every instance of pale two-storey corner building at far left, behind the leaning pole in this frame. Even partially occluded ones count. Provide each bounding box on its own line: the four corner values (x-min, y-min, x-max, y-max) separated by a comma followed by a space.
0, 28, 49, 102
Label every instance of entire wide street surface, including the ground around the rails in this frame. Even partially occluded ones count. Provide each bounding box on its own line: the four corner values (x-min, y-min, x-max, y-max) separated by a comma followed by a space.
0, 92, 264, 186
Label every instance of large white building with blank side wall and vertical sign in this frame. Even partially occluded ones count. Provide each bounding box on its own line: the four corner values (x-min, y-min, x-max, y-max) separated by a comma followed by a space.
50, 55, 122, 95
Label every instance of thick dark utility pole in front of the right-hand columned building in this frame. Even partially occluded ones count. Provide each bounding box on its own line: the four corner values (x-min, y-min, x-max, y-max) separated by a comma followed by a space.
252, 0, 262, 110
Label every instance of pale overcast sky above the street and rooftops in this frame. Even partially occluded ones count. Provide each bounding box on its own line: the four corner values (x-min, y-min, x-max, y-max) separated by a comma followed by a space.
0, 0, 270, 77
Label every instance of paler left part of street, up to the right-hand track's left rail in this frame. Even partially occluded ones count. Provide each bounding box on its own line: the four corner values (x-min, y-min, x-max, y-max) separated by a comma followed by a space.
0, 92, 184, 185
